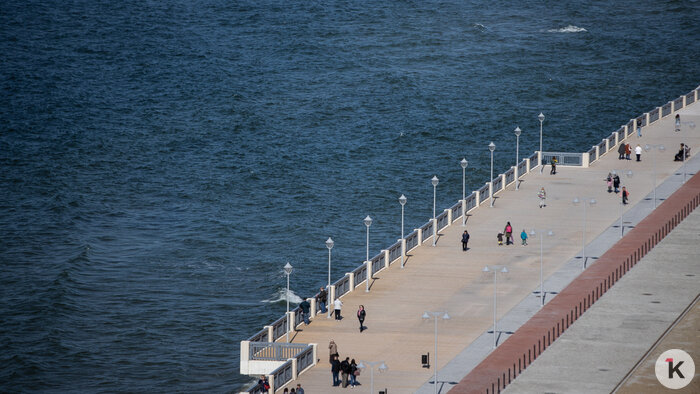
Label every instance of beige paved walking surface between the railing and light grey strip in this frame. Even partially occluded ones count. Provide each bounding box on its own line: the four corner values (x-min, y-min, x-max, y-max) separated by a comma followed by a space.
280, 97, 700, 393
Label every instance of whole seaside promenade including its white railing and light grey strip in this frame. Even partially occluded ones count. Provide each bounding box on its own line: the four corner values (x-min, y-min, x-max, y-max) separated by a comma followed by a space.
241, 88, 700, 394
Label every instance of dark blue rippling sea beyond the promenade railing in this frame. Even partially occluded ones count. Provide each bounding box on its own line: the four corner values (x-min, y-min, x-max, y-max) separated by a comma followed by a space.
0, 0, 700, 392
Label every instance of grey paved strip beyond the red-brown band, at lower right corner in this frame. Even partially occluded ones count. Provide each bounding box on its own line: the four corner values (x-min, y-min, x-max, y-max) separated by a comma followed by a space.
504, 209, 700, 393
